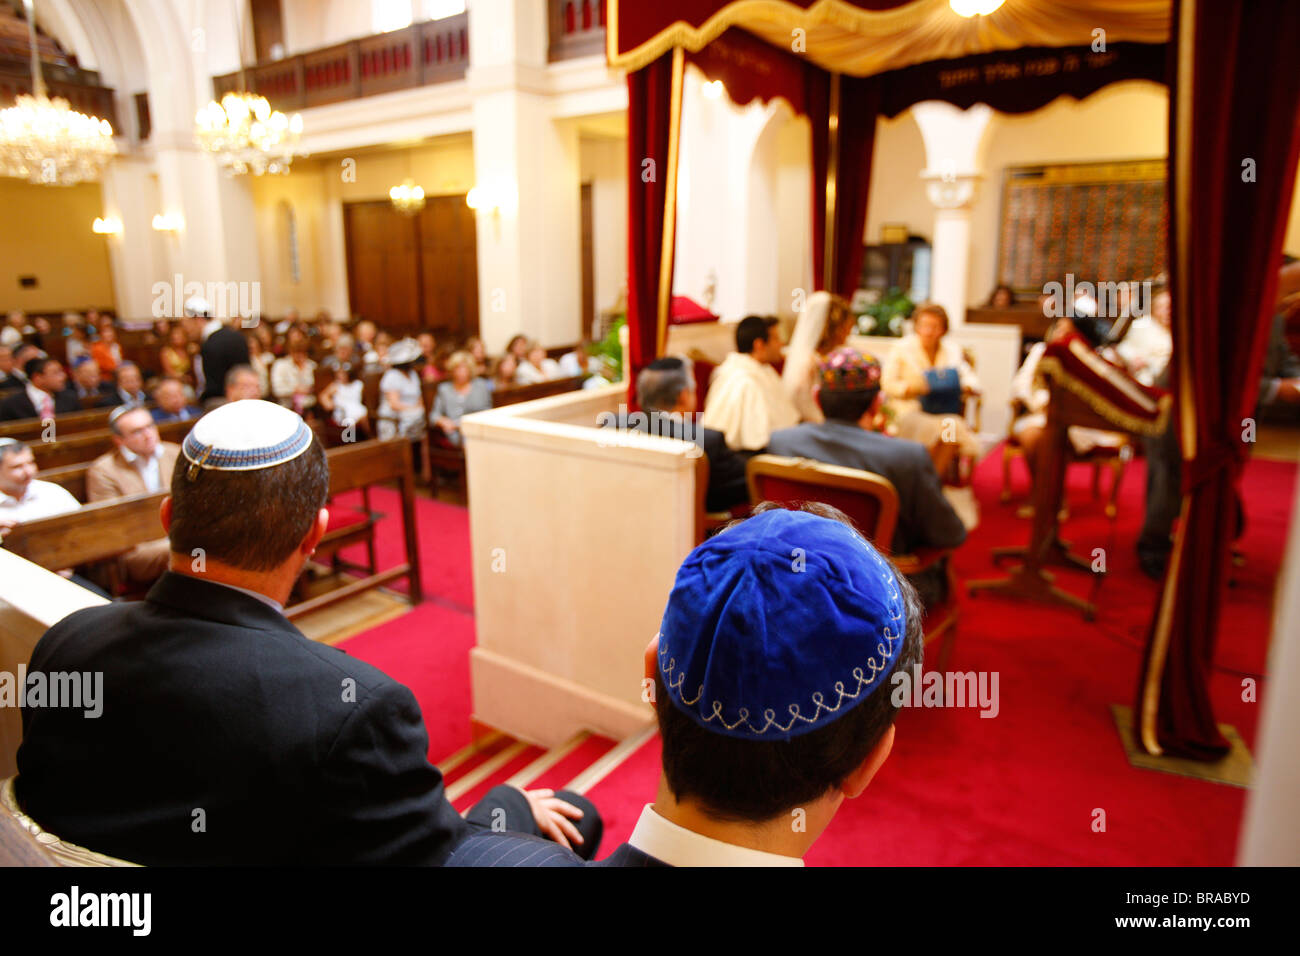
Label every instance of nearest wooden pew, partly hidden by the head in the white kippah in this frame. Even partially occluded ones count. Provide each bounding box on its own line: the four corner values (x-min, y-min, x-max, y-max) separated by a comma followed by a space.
4, 442, 423, 619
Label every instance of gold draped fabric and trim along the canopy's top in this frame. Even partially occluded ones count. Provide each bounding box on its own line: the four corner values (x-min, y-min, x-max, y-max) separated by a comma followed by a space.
606, 0, 1173, 77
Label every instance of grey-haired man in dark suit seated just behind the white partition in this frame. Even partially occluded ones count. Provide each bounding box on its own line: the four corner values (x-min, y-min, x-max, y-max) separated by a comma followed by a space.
598, 356, 755, 511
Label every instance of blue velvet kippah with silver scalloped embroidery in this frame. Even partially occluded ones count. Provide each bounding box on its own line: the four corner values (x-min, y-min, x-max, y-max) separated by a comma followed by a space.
659, 510, 907, 740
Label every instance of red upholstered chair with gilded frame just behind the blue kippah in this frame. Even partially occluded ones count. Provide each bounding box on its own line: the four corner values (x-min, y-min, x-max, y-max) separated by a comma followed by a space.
745, 455, 961, 672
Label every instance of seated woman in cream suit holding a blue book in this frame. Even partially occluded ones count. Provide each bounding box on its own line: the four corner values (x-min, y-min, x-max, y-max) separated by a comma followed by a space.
880, 303, 980, 475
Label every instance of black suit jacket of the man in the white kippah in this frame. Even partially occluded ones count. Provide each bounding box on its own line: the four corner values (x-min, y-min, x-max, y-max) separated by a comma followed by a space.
17, 572, 471, 865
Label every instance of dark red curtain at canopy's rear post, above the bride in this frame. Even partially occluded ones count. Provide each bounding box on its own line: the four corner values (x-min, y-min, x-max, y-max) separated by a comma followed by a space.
807, 72, 881, 299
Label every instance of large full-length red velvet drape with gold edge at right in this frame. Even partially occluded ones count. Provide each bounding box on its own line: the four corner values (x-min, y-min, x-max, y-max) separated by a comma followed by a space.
1136, 0, 1300, 760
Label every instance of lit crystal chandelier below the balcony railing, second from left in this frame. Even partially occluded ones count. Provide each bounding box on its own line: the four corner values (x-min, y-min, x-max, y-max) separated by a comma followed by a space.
194, 92, 303, 176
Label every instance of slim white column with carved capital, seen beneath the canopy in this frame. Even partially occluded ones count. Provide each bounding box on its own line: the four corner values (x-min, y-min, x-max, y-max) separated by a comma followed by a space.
913, 103, 993, 328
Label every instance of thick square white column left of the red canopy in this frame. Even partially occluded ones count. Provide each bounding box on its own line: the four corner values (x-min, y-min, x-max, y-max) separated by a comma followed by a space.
465, 0, 582, 352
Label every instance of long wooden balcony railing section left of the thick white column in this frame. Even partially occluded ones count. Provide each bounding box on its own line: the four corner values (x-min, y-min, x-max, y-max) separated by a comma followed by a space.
212, 13, 469, 111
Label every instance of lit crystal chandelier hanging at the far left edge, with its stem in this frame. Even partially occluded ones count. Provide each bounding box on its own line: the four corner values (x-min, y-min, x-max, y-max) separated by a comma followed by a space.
0, 0, 117, 186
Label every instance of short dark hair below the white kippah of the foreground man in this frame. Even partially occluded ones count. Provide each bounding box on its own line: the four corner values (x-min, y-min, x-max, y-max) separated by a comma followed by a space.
168, 438, 329, 571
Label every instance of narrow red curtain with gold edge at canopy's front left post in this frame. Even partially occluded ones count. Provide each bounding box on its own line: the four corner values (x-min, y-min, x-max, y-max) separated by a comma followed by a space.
628, 52, 673, 407
